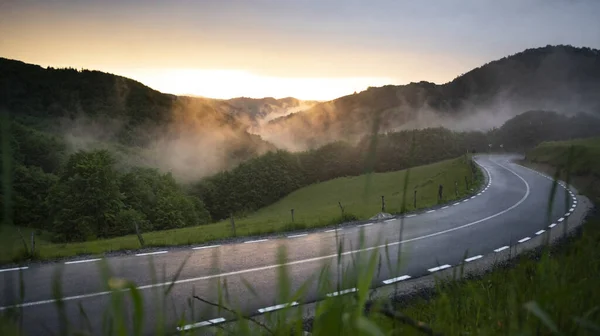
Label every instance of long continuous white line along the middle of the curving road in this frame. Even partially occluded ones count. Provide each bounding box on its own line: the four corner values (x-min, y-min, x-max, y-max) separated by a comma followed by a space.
0, 159, 531, 311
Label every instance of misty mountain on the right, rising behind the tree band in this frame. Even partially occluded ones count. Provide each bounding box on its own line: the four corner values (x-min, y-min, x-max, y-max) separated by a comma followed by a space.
258, 46, 600, 150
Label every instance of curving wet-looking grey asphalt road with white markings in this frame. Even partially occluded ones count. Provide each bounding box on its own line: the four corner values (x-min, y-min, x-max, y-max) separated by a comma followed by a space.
0, 155, 577, 335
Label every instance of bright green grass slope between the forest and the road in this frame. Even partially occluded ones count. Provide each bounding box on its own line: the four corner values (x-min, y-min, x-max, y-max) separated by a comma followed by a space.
0, 157, 482, 263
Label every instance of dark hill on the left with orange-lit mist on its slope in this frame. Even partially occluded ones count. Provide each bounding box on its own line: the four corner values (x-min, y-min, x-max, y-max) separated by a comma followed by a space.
0, 58, 274, 178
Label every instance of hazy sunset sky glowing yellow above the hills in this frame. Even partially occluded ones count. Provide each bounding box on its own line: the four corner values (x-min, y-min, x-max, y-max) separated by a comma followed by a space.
0, 0, 600, 99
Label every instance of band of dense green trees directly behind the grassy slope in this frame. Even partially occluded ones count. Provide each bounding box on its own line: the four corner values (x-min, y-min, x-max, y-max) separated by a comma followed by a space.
0, 111, 600, 242
